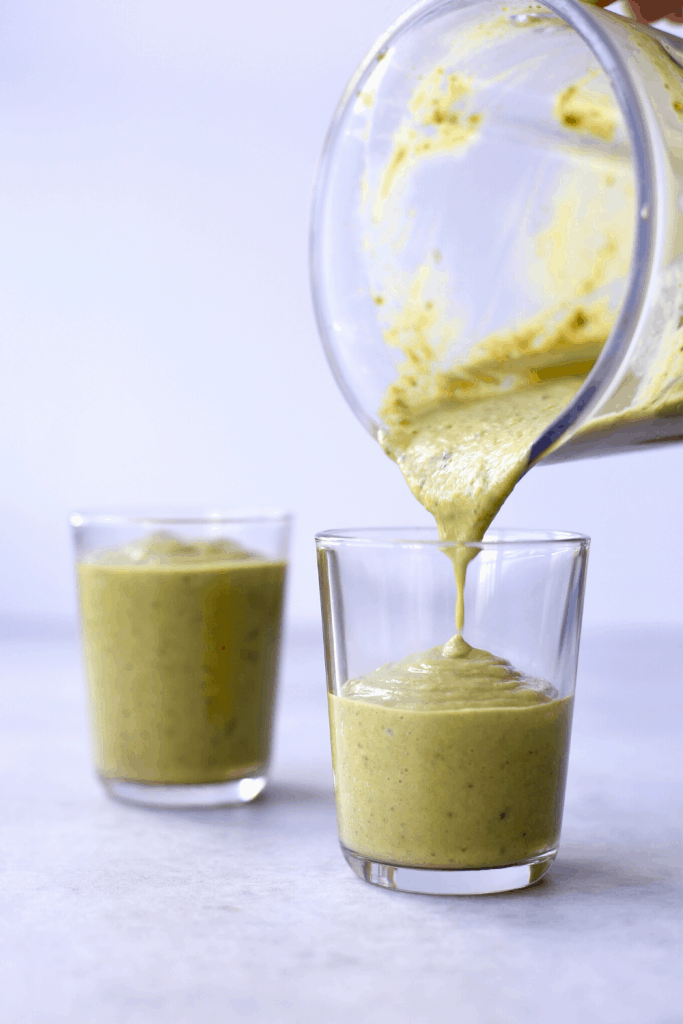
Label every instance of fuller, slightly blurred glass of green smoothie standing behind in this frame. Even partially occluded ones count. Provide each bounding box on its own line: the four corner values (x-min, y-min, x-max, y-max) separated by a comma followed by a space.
71, 511, 290, 806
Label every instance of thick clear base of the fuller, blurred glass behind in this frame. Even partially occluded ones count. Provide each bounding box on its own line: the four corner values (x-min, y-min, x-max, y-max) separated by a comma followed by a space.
99, 775, 266, 807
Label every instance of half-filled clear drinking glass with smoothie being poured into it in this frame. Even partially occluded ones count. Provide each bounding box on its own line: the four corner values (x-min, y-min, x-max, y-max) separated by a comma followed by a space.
316, 528, 589, 895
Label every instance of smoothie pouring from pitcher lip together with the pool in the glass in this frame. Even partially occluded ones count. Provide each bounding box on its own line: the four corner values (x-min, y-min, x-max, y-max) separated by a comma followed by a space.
329, 327, 581, 869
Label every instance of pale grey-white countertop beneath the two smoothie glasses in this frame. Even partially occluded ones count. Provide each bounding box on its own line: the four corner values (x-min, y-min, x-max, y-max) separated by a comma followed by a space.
0, 628, 683, 1024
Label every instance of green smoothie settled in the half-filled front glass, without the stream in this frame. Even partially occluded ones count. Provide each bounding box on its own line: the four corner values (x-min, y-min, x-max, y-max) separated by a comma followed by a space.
329, 640, 572, 868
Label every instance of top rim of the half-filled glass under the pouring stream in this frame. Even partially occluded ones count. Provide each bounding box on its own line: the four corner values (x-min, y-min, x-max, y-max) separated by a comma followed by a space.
315, 526, 591, 551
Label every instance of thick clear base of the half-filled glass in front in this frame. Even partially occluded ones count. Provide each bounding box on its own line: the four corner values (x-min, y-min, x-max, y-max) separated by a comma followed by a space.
340, 844, 557, 896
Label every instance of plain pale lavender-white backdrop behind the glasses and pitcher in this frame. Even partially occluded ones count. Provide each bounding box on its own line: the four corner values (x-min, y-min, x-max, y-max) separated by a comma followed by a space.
0, 0, 683, 625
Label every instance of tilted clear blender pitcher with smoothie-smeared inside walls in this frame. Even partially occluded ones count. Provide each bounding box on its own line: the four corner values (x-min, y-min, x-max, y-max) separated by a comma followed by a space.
311, 0, 683, 465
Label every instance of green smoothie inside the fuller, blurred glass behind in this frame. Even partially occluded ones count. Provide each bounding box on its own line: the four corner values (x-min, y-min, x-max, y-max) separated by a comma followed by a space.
78, 534, 286, 784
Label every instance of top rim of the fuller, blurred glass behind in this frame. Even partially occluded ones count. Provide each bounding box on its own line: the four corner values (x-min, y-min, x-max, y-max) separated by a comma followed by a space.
69, 507, 293, 528
